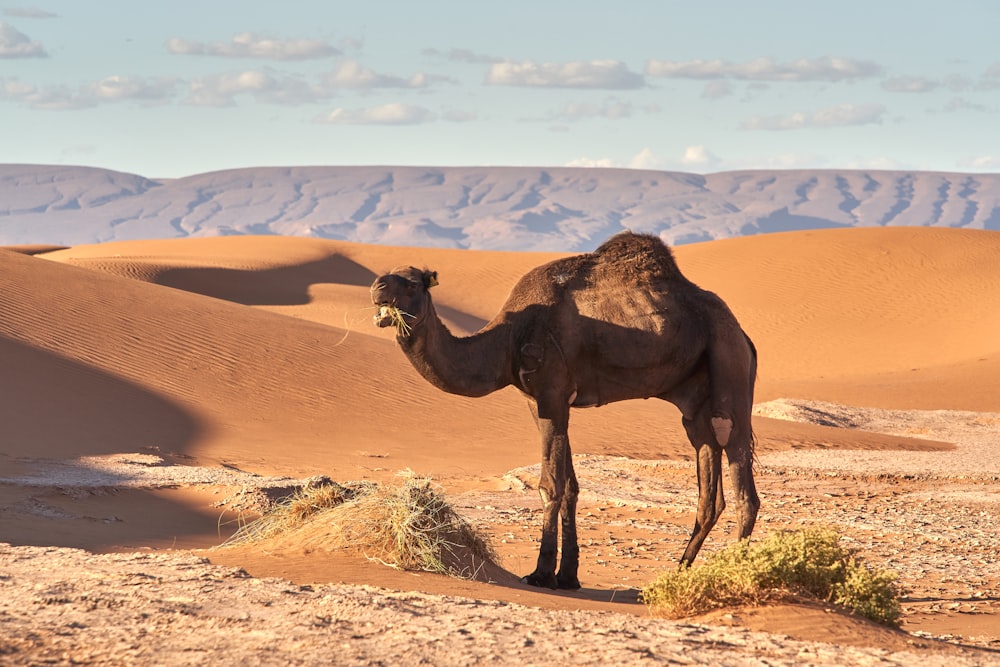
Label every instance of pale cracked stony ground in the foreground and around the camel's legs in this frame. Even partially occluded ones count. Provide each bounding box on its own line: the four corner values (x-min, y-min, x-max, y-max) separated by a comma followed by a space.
0, 402, 1000, 667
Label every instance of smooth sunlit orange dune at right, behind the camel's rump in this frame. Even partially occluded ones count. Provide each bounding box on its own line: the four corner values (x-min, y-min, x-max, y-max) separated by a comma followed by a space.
677, 228, 1000, 410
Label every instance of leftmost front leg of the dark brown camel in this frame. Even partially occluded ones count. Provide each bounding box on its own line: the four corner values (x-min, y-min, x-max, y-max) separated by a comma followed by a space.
521, 404, 579, 588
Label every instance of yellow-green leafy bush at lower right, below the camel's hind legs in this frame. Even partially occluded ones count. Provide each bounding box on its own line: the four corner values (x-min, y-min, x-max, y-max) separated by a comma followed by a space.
641, 528, 900, 626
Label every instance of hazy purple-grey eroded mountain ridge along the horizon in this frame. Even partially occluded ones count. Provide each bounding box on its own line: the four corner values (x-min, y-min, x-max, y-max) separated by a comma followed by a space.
0, 165, 1000, 252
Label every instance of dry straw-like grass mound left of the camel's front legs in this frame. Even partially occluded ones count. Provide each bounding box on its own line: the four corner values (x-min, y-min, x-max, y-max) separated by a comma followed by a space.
226, 471, 496, 578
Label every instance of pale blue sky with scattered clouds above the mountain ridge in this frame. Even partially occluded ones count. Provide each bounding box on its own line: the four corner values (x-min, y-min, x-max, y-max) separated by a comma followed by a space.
0, 0, 1000, 177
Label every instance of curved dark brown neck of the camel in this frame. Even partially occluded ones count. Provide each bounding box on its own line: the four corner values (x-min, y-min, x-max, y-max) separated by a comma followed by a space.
397, 303, 511, 397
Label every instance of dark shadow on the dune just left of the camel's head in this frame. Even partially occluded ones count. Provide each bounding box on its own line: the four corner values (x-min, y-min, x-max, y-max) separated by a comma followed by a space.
153, 255, 375, 306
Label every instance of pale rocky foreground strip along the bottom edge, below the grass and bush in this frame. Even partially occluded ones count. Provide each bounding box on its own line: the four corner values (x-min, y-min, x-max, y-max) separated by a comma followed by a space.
0, 547, 1000, 666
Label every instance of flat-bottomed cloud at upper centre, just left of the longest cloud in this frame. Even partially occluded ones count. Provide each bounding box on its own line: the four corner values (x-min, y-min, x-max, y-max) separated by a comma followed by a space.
486, 60, 646, 90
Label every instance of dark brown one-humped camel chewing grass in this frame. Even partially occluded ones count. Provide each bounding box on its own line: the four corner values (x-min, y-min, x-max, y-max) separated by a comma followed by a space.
371, 233, 760, 589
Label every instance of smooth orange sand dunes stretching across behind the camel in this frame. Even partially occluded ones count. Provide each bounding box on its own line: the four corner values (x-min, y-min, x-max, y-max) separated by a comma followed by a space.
0, 228, 1000, 664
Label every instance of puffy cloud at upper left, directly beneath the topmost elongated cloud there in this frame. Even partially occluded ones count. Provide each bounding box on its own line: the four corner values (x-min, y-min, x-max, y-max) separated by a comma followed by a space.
183, 70, 318, 107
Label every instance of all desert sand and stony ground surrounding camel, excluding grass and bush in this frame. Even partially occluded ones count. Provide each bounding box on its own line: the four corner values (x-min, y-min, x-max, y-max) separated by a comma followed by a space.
0, 228, 1000, 665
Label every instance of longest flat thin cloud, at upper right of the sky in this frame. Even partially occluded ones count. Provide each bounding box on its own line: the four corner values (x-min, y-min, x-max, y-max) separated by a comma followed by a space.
646, 57, 882, 81
